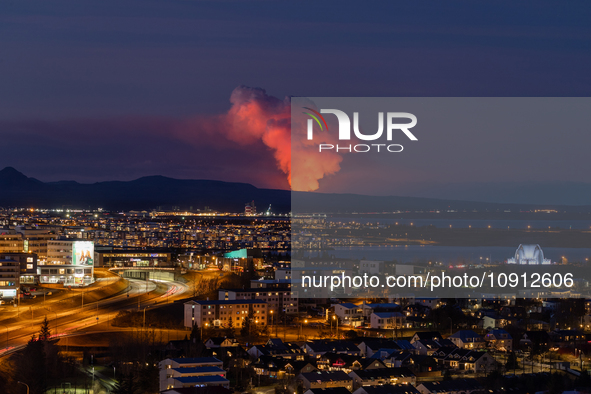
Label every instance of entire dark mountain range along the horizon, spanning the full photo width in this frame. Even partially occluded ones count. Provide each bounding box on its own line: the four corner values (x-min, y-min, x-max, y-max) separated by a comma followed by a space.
0, 167, 591, 213
